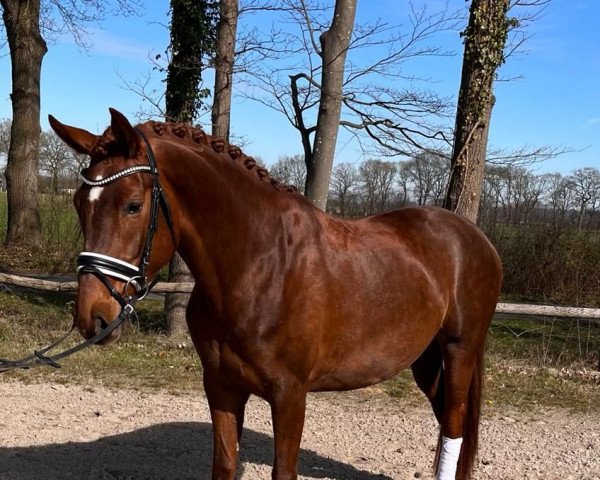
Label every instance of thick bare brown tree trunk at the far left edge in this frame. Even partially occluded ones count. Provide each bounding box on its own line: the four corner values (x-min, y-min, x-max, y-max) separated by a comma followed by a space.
0, 0, 47, 245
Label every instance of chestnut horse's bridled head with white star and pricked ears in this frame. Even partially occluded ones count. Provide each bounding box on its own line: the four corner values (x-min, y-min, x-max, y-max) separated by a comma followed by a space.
49, 109, 175, 344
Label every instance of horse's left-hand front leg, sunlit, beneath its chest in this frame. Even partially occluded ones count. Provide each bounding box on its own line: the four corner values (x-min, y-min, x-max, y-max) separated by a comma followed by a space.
204, 373, 249, 480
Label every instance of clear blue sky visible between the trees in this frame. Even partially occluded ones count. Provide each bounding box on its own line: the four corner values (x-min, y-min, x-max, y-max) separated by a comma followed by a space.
0, 0, 600, 173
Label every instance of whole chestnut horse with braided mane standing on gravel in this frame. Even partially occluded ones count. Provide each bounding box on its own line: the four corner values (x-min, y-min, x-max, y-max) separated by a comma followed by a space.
50, 109, 502, 480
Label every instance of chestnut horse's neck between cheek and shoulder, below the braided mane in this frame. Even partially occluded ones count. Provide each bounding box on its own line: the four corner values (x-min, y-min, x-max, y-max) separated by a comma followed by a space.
159, 143, 285, 283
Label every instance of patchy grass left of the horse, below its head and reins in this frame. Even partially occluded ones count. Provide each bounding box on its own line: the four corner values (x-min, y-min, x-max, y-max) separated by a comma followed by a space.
0, 292, 201, 392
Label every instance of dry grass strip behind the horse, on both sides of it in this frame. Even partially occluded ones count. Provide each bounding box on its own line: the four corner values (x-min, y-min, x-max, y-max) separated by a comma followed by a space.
0, 291, 600, 412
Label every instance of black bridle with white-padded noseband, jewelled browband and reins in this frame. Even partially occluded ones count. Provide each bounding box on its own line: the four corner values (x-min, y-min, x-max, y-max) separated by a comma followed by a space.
0, 129, 177, 373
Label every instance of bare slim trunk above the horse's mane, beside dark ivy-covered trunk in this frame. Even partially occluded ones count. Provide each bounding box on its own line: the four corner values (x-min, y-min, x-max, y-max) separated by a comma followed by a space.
212, 0, 238, 141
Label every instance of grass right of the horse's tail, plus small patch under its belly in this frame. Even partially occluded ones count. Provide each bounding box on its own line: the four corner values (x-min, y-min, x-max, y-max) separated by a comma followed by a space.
384, 318, 600, 412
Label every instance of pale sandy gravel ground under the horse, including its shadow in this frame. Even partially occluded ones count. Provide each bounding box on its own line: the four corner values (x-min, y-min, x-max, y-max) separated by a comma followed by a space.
0, 381, 600, 480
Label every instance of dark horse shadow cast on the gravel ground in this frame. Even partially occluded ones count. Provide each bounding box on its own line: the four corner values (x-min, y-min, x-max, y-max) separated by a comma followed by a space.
0, 422, 391, 480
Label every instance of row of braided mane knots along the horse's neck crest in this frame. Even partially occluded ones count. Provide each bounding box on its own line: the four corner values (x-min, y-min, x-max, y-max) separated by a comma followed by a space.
139, 121, 298, 193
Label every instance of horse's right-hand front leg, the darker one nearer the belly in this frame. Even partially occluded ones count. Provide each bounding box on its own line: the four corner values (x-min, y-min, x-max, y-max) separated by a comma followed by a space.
270, 380, 307, 480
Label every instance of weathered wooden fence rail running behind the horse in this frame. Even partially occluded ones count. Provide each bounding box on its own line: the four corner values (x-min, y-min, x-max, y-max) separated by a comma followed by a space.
0, 273, 600, 319
